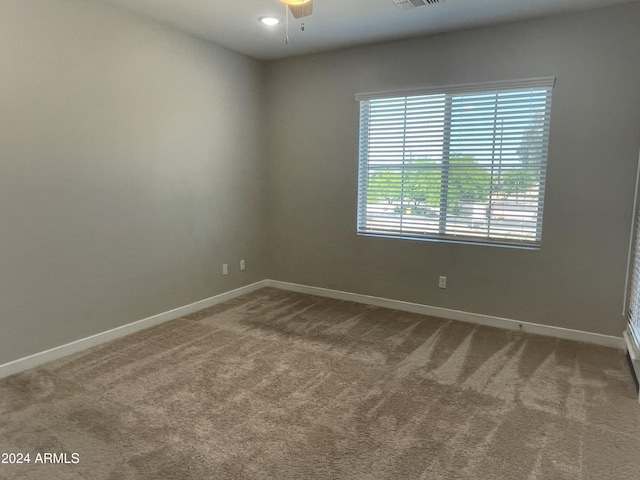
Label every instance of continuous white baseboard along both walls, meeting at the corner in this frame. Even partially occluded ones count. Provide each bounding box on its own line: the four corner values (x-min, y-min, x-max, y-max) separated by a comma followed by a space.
0, 280, 625, 378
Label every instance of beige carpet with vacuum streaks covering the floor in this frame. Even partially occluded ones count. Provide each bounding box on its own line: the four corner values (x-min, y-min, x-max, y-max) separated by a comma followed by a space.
0, 289, 640, 480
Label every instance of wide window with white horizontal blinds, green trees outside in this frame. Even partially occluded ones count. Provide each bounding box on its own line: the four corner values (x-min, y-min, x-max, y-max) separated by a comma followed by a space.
356, 78, 554, 248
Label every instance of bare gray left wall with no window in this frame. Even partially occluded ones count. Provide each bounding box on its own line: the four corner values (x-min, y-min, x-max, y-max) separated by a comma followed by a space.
0, 0, 267, 364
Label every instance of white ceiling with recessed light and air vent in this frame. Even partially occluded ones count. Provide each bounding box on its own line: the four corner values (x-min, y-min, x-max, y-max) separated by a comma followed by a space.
103, 0, 636, 60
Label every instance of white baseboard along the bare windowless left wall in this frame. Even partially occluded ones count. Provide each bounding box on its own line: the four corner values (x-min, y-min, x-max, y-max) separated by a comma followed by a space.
0, 280, 266, 378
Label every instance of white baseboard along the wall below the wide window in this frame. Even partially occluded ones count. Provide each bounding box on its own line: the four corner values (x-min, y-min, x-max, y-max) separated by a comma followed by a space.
265, 280, 625, 349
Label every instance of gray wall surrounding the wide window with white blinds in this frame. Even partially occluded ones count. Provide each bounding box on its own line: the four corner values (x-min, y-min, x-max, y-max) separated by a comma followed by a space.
265, 3, 640, 336
